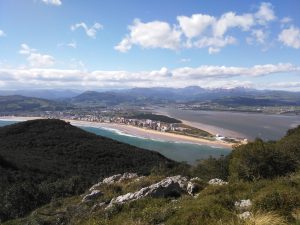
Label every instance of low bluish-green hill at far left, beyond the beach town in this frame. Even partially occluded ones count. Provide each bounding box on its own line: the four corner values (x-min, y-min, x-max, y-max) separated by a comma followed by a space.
0, 95, 70, 113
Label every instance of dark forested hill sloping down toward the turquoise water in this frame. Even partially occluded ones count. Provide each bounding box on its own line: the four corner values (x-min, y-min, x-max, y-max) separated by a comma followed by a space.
0, 119, 175, 220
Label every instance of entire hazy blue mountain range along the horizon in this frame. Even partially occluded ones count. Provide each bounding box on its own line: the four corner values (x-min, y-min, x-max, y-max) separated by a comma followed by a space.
0, 86, 300, 112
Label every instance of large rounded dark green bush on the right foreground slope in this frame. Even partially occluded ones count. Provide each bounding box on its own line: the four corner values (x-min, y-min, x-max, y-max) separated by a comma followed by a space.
229, 139, 298, 181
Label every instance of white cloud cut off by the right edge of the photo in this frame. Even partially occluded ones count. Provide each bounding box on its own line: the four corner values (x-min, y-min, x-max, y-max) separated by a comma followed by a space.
278, 26, 300, 49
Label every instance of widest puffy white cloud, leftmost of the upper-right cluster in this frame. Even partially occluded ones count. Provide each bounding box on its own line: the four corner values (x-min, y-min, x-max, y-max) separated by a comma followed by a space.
115, 19, 181, 52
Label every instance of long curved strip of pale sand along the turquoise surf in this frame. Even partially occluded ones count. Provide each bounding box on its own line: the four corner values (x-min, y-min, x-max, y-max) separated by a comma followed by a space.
0, 117, 233, 150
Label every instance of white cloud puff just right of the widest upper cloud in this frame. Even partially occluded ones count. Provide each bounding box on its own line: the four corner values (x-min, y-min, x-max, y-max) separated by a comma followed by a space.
177, 14, 216, 38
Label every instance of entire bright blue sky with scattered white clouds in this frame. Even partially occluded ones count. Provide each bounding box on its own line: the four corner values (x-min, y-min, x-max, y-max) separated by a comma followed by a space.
0, 0, 300, 91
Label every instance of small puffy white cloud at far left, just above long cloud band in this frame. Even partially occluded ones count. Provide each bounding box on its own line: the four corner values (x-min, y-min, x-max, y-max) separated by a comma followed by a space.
19, 44, 55, 67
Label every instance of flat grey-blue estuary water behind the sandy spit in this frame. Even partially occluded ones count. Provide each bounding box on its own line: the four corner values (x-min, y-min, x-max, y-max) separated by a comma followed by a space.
158, 108, 300, 140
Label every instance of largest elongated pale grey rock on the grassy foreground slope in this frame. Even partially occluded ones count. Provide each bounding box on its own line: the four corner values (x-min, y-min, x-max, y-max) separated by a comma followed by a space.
107, 176, 187, 208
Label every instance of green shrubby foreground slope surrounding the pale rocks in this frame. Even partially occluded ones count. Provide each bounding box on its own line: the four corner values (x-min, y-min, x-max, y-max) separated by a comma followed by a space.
0, 120, 300, 225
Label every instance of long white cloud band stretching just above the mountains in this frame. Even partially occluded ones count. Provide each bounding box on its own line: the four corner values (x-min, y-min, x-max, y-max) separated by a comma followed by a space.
0, 62, 300, 88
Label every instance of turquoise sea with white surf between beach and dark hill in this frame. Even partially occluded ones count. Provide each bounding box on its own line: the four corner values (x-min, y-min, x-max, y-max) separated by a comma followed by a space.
0, 120, 230, 164
